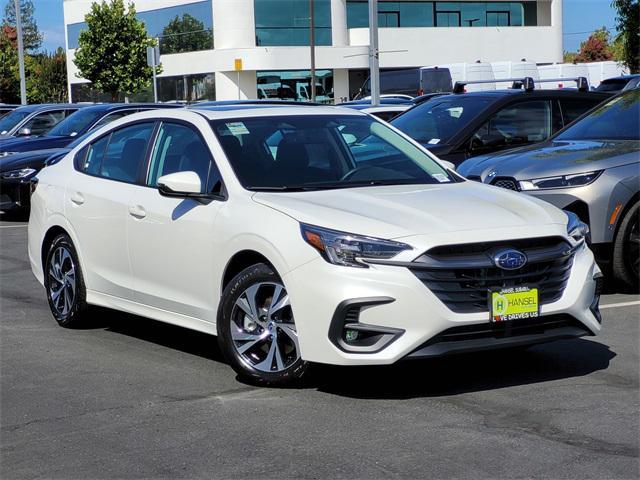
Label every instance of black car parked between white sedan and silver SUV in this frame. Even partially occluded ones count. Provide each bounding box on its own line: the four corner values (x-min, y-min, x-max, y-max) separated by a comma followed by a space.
391, 82, 610, 165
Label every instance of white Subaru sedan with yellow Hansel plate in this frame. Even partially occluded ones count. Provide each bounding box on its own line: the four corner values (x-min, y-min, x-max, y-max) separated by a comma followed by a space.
29, 106, 602, 385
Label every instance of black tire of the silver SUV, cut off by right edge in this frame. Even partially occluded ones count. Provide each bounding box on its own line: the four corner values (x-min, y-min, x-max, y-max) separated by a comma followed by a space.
612, 202, 640, 291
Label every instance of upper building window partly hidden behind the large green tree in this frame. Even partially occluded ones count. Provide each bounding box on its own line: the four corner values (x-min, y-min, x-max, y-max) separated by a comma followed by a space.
67, 0, 213, 54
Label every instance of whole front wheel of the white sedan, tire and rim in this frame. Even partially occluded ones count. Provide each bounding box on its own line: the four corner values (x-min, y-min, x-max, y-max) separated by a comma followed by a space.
217, 263, 307, 386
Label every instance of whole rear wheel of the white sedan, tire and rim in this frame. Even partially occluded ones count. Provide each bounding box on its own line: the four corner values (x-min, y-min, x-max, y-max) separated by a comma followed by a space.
44, 234, 87, 328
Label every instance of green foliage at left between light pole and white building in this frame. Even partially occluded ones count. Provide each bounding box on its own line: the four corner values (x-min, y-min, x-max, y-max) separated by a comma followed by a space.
26, 48, 68, 103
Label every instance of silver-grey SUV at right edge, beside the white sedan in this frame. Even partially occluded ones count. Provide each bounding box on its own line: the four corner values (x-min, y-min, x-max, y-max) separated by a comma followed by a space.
458, 89, 640, 289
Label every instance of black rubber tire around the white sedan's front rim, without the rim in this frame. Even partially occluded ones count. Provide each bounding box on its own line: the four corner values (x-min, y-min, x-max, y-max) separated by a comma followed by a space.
217, 263, 307, 386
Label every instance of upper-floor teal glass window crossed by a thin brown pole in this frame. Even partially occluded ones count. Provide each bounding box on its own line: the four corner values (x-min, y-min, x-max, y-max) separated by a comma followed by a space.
254, 0, 331, 46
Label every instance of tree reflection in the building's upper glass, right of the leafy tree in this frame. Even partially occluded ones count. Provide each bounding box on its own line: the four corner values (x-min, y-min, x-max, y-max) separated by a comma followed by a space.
160, 13, 213, 54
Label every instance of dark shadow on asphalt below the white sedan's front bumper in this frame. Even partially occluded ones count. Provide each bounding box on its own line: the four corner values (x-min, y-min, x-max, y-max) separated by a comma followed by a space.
310, 339, 616, 399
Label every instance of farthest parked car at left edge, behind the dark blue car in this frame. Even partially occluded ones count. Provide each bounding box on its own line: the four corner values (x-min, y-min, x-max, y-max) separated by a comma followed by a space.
0, 103, 87, 144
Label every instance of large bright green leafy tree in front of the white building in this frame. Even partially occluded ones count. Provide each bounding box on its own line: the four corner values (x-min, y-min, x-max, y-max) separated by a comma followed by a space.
74, 0, 160, 101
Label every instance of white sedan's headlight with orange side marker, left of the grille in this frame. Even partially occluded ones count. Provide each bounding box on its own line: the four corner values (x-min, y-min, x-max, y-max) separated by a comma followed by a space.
300, 223, 411, 268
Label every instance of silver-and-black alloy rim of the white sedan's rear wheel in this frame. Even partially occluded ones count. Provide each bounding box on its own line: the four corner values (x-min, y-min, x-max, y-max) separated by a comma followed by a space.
48, 246, 76, 316
